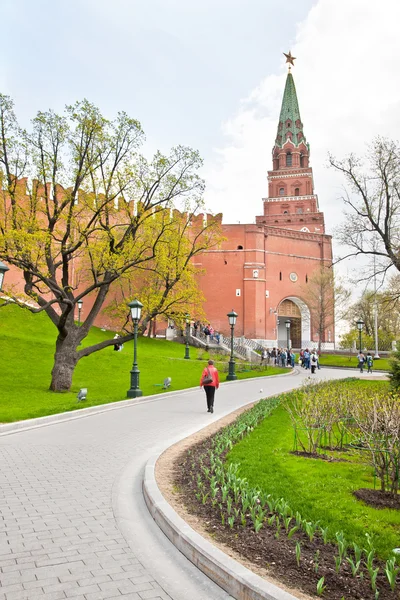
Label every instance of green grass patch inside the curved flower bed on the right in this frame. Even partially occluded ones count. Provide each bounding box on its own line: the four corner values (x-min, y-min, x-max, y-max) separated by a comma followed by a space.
227, 381, 400, 558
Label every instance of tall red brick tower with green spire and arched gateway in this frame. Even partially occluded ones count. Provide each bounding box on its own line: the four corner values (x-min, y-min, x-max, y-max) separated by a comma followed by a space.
199, 61, 334, 348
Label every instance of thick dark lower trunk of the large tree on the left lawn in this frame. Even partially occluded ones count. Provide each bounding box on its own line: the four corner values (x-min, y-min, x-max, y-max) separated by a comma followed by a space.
50, 333, 79, 392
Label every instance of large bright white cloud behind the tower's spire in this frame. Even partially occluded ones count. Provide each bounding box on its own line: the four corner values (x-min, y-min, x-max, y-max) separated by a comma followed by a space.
205, 0, 400, 251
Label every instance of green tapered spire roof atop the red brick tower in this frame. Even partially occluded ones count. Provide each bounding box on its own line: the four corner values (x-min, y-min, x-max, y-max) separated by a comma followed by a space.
275, 72, 308, 147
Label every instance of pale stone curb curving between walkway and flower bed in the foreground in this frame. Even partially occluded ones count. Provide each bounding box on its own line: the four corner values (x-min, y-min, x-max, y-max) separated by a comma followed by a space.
143, 455, 298, 600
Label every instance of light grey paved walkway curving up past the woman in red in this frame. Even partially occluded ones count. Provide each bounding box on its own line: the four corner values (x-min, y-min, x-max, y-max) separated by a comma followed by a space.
0, 367, 384, 600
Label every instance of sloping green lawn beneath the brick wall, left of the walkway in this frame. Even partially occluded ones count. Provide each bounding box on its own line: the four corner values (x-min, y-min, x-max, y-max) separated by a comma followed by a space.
0, 305, 287, 423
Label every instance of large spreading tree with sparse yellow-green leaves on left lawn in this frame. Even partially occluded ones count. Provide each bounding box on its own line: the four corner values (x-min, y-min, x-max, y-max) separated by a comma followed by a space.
0, 95, 220, 391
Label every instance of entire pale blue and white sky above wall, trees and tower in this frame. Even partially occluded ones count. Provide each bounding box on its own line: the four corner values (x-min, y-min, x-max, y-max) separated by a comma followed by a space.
0, 0, 400, 276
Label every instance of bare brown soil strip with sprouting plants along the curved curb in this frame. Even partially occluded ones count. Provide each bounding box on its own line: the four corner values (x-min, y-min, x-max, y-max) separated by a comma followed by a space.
156, 406, 399, 600
